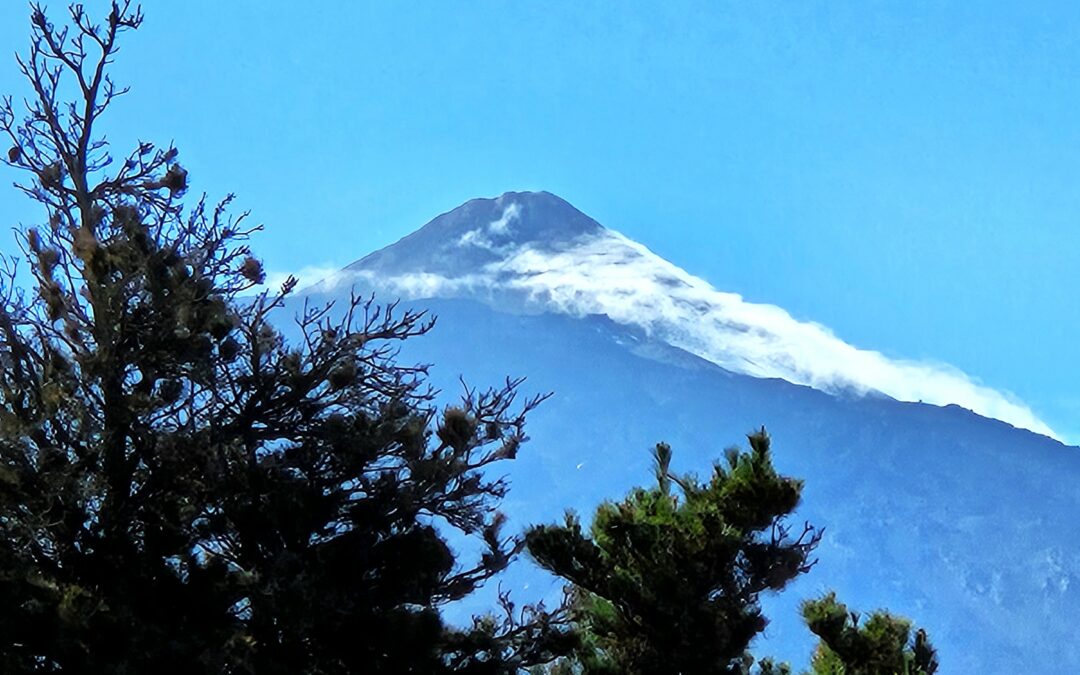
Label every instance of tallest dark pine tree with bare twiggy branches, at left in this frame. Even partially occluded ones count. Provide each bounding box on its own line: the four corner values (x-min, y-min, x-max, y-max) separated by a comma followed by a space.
0, 1, 571, 675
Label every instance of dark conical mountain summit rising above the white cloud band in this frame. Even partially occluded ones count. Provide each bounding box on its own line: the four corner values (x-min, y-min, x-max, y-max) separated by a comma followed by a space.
346, 192, 604, 275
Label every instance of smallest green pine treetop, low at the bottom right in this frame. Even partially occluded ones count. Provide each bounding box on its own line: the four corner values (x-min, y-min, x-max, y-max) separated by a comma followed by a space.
802, 593, 937, 675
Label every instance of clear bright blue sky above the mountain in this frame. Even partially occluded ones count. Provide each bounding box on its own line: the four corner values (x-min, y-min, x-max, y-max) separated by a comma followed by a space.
6, 0, 1080, 442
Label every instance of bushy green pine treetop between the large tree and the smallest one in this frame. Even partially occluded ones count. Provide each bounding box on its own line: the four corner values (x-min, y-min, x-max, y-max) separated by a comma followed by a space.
526, 429, 821, 675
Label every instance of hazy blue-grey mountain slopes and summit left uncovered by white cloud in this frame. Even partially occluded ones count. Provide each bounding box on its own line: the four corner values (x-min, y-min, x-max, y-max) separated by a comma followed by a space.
297, 195, 1080, 674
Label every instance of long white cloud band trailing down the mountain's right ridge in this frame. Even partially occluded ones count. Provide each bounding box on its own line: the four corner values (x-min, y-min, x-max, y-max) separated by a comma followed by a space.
326, 230, 1058, 437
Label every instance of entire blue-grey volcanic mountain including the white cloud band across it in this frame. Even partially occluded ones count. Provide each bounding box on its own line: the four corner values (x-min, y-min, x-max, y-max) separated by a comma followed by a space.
295, 193, 1080, 674
